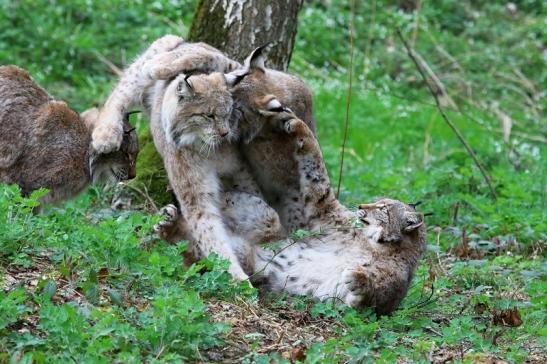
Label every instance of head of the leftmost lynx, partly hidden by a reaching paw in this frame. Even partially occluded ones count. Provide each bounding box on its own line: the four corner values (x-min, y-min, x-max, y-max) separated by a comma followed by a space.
80, 108, 139, 184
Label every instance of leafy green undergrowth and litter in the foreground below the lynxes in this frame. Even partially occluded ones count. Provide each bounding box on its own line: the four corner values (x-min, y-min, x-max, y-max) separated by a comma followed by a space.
0, 186, 547, 363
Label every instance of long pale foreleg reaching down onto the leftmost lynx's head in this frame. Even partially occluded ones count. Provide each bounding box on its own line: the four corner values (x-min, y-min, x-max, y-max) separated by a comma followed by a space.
92, 35, 184, 154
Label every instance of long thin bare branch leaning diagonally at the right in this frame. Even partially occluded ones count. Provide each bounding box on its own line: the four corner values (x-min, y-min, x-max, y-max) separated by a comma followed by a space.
397, 29, 497, 200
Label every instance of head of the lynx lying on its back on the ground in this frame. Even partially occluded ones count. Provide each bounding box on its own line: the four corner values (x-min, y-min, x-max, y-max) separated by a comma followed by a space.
357, 198, 425, 244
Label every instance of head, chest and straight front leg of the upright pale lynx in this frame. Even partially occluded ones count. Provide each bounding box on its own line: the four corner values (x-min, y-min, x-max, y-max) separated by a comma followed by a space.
150, 73, 268, 280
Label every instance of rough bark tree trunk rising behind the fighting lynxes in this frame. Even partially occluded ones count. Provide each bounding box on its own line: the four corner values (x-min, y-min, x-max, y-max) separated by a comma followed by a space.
188, 0, 304, 71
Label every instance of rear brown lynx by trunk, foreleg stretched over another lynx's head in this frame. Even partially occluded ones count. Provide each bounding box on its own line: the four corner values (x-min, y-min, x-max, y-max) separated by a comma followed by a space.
93, 39, 315, 231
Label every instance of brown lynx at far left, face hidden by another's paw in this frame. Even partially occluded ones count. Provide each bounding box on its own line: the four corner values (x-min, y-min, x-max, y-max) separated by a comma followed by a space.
0, 66, 138, 203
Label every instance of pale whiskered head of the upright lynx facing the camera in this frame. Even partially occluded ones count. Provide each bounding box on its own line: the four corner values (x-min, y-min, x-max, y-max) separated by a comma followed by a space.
161, 72, 242, 152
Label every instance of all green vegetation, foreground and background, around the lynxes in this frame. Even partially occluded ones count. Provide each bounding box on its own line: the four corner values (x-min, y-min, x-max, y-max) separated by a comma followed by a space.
0, 0, 547, 363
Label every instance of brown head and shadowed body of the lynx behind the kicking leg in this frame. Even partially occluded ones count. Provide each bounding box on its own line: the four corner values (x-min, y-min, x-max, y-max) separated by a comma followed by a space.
232, 51, 315, 232
